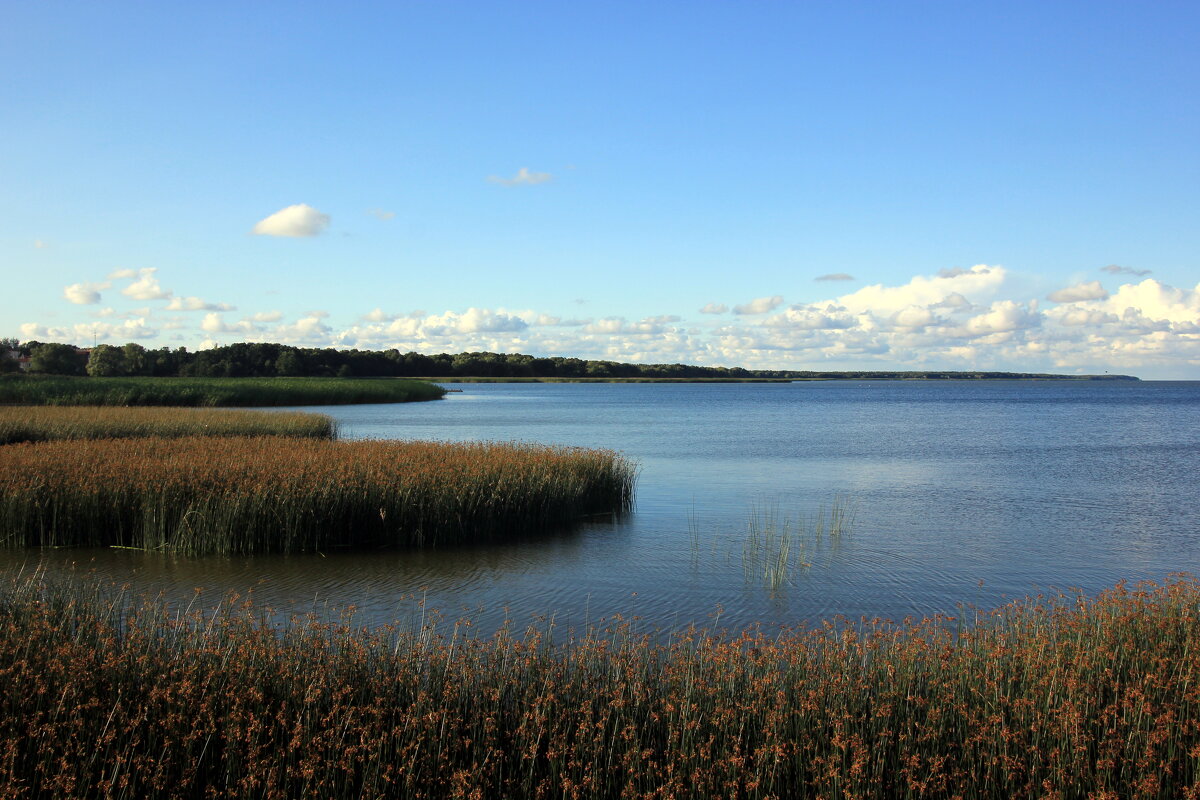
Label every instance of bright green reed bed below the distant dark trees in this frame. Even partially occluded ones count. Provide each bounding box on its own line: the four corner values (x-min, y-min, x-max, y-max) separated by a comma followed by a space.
0, 375, 445, 407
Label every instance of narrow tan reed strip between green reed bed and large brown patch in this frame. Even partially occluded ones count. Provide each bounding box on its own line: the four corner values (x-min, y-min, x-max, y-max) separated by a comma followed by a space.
0, 405, 337, 445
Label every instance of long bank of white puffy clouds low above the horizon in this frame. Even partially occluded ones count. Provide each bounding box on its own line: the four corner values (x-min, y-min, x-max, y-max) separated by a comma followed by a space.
20, 264, 1200, 377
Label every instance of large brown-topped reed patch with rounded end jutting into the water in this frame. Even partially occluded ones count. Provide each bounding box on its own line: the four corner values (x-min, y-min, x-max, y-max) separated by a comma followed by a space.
0, 437, 636, 554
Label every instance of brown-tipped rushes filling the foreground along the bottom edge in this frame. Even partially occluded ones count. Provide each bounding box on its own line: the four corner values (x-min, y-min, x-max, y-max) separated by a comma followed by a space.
0, 577, 1200, 800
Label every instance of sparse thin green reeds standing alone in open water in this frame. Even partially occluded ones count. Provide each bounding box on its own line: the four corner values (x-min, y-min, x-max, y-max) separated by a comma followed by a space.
742, 497, 854, 593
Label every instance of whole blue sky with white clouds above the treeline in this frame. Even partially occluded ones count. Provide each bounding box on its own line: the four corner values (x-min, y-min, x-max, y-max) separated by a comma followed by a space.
0, 0, 1200, 379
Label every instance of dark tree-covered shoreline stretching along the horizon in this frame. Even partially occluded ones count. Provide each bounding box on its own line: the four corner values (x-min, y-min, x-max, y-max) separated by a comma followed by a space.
0, 339, 1138, 383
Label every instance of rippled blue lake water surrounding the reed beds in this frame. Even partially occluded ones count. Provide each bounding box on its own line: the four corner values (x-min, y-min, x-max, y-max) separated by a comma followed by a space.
9, 381, 1200, 630
